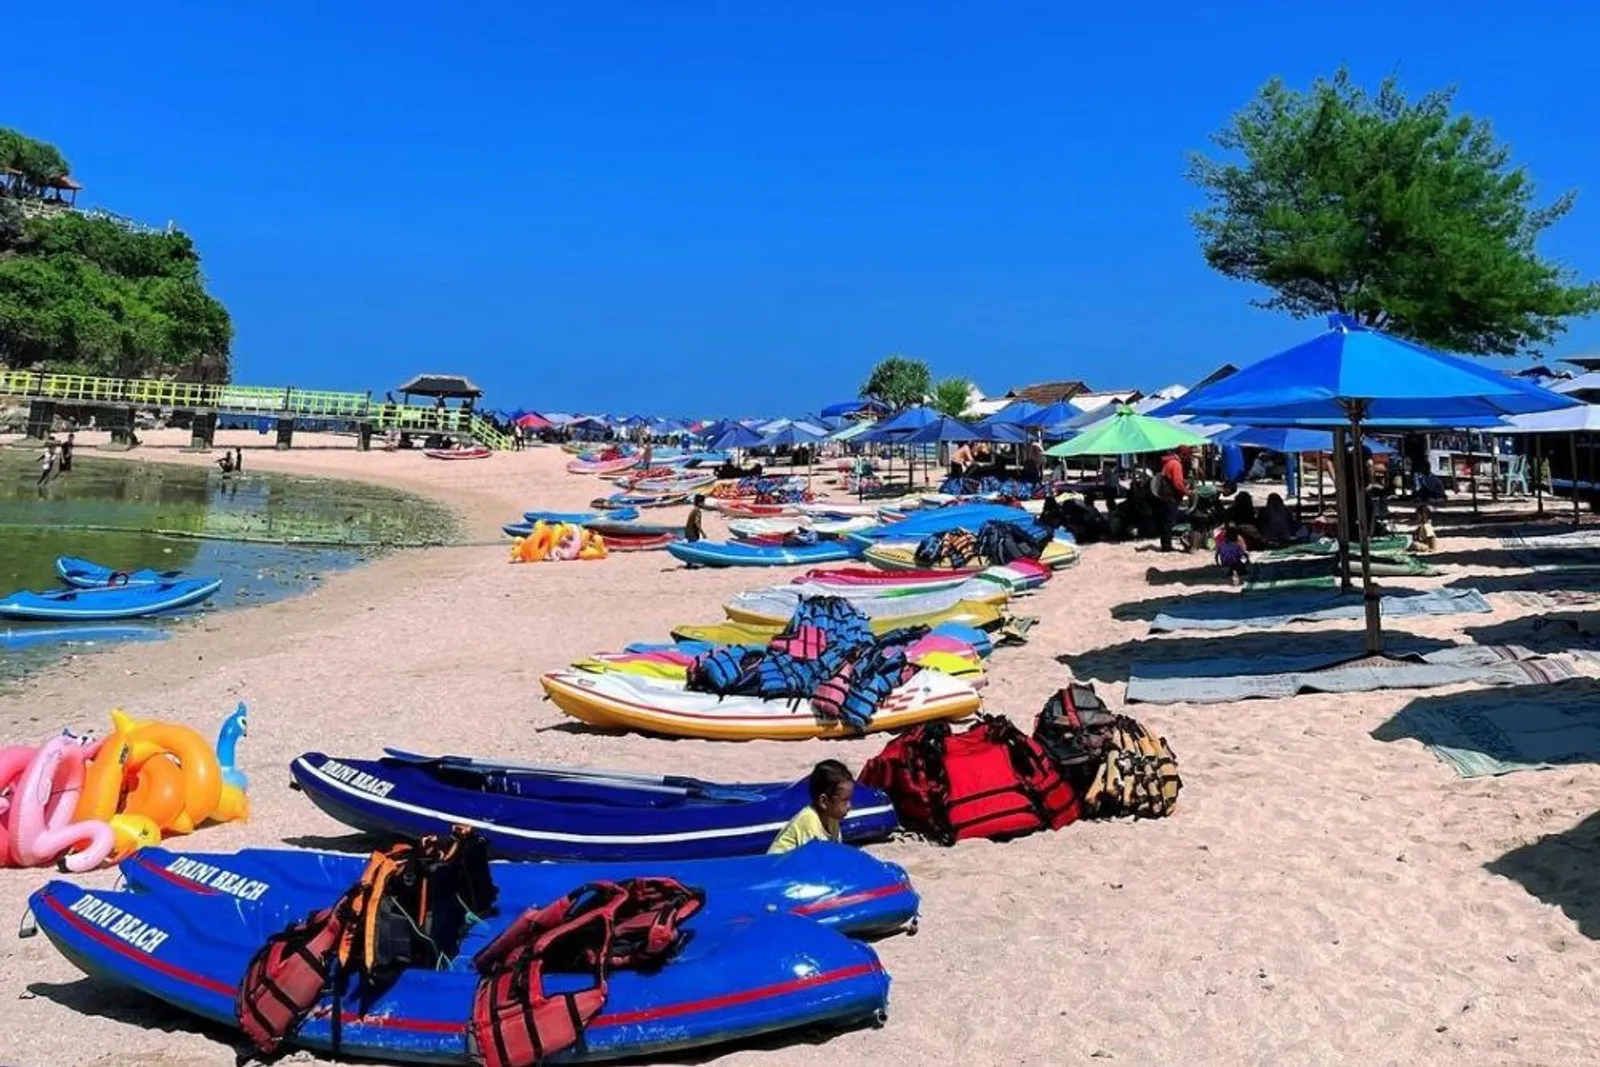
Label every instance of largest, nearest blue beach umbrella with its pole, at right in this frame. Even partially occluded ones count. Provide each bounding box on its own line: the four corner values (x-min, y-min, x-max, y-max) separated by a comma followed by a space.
1160, 315, 1576, 656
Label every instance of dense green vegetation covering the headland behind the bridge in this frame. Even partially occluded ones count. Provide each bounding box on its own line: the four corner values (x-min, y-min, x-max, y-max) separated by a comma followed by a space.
0, 131, 234, 381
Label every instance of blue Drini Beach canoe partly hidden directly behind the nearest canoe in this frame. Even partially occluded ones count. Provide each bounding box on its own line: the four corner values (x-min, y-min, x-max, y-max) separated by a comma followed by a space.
118, 841, 920, 937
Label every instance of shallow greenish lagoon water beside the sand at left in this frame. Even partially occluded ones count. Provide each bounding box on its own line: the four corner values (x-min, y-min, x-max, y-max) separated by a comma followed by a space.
0, 450, 458, 680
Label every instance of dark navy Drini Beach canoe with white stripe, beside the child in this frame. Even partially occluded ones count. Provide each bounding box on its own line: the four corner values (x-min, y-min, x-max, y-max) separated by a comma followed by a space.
290, 749, 898, 861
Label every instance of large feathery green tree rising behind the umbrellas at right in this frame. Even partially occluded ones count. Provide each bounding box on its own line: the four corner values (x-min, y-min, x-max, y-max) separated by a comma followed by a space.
1189, 69, 1600, 355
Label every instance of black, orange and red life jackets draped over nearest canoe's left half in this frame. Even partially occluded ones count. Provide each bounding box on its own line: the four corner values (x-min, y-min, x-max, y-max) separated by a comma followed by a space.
234, 832, 496, 1054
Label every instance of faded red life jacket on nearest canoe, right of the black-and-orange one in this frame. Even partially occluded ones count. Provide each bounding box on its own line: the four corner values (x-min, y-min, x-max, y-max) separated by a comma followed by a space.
467, 878, 706, 1067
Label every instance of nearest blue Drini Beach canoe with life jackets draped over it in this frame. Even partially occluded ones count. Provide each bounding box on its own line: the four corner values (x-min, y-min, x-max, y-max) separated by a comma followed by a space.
29, 880, 890, 1064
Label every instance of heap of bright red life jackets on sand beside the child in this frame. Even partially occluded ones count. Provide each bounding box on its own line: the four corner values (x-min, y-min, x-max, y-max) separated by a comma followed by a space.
861, 715, 1082, 845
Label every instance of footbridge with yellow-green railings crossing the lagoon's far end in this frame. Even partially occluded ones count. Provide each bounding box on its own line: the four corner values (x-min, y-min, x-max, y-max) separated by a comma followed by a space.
0, 371, 510, 450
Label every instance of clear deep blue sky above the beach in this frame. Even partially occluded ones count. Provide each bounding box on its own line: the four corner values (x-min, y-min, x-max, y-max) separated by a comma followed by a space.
12, 0, 1600, 414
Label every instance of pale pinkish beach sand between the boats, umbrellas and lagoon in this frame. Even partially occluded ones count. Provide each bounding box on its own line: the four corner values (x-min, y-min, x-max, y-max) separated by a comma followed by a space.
0, 434, 1600, 1067
